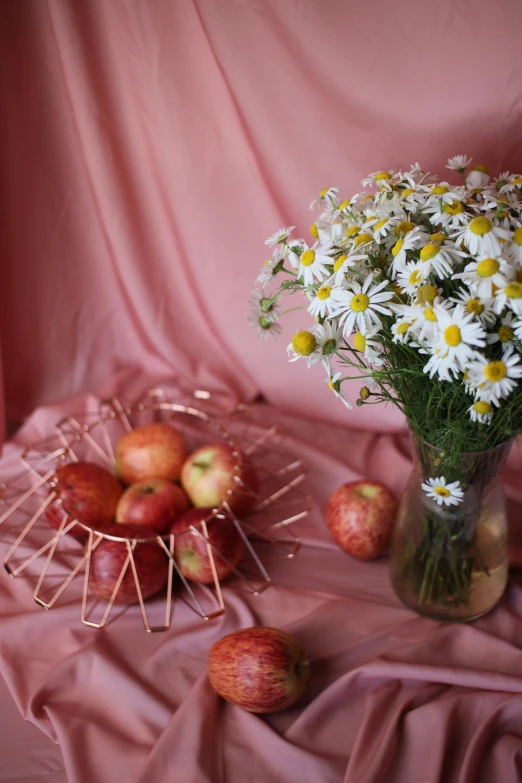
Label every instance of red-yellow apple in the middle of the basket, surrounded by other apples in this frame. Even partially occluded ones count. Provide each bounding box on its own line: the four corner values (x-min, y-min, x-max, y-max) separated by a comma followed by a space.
116, 479, 189, 535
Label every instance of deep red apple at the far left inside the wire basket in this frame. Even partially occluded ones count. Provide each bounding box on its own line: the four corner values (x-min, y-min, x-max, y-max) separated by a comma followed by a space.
56, 462, 123, 529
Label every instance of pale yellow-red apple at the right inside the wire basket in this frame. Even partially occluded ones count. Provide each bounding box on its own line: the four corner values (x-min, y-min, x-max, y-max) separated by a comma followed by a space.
181, 443, 258, 516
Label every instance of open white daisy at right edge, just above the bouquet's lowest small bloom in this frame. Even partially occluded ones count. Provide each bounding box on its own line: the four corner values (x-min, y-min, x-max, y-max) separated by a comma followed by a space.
466, 345, 522, 407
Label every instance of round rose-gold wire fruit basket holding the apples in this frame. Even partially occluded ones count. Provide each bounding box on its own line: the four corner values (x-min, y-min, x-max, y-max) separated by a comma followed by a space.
0, 388, 310, 633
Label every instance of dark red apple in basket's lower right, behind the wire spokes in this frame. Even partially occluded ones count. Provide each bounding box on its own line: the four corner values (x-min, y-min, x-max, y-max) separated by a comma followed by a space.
171, 508, 244, 584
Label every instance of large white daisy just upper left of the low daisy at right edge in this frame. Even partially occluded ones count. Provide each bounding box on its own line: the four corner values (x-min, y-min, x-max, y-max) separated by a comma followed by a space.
424, 305, 486, 380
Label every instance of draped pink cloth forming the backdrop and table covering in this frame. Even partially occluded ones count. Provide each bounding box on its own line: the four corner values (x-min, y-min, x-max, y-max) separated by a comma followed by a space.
0, 0, 522, 783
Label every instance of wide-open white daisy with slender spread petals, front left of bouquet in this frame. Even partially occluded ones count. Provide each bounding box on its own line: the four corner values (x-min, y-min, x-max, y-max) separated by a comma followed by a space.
330, 275, 393, 337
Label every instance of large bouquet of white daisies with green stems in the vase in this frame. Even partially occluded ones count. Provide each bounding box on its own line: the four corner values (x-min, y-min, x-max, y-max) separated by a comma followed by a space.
250, 155, 522, 605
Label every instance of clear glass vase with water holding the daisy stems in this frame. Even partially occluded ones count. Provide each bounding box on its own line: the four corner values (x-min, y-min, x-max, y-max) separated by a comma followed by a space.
390, 436, 513, 621
